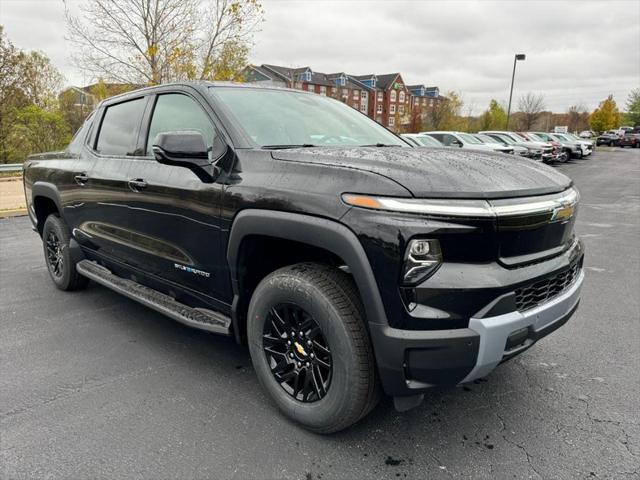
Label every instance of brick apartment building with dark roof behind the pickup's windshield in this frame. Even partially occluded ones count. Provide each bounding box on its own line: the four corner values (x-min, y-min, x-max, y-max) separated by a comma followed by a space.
244, 64, 440, 131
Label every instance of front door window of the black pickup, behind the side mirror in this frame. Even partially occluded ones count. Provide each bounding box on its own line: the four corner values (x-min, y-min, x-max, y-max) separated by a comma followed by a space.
147, 93, 215, 155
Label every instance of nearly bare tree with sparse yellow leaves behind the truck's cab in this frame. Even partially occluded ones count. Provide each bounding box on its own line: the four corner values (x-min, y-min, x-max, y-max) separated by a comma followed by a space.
66, 0, 264, 84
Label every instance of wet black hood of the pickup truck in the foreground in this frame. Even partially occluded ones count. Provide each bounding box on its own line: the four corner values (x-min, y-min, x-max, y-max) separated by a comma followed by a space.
271, 147, 572, 198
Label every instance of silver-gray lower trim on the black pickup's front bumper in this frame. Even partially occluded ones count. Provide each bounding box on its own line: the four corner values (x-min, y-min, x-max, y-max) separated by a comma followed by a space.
460, 270, 584, 383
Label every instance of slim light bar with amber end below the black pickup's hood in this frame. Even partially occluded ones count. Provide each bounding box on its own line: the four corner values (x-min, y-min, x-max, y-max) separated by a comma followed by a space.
342, 188, 579, 218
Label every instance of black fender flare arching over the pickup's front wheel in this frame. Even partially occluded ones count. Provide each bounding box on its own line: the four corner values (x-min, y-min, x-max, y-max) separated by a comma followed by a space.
227, 209, 388, 338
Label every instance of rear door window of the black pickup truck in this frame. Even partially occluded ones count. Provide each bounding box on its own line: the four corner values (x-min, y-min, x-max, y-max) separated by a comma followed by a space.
96, 98, 146, 156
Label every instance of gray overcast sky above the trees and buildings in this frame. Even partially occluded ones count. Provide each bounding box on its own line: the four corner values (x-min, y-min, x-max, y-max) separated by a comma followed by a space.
0, 0, 640, 113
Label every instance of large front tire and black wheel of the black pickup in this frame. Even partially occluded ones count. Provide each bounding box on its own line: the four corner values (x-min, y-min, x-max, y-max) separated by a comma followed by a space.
247, 263, 379, 434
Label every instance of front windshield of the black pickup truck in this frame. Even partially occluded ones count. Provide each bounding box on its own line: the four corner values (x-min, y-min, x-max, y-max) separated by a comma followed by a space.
210, 87, 410, 148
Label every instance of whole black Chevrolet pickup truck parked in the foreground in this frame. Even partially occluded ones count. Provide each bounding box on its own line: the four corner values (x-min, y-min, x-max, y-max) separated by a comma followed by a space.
24, 83, 584, 433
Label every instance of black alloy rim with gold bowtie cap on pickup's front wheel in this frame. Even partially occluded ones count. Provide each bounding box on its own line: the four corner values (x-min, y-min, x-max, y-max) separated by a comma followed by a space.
262, 303, 333, 403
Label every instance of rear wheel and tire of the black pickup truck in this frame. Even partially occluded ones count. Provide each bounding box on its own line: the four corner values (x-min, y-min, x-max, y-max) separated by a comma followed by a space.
42, 214, 89, 291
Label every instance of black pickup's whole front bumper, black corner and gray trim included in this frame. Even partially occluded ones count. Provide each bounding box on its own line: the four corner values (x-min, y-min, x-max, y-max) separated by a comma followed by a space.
369, 258, 584, 397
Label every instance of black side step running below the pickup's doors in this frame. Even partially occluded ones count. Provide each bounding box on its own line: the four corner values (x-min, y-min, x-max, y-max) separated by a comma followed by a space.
76, 260, 231, 335
